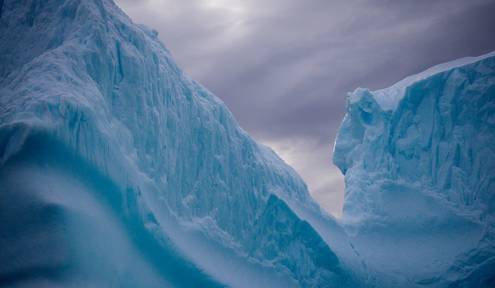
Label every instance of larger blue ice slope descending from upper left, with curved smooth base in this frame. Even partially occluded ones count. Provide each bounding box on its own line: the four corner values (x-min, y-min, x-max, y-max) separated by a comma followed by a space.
0, 0, 357, 287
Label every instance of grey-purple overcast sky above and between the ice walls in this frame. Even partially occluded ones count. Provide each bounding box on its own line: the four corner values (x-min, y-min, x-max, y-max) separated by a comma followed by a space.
117, 0, 495, 215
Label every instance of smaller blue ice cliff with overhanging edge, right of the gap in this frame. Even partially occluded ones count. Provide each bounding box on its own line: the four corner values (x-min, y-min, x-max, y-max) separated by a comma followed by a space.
333, 52, 495, 287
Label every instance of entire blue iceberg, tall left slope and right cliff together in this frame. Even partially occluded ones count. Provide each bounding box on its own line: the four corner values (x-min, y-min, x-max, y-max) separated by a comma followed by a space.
0, 0, 495, 287
